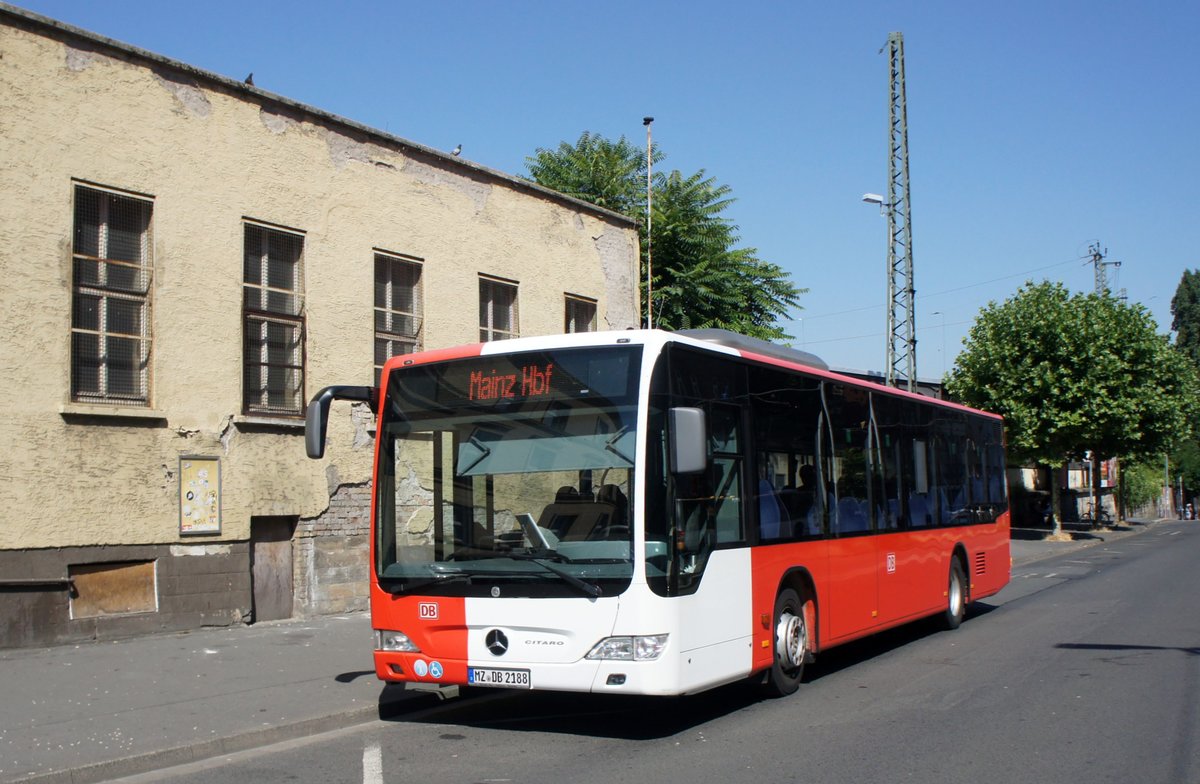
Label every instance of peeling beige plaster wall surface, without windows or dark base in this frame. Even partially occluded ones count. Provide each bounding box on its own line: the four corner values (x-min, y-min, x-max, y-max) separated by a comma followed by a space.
0, 13, 637, 550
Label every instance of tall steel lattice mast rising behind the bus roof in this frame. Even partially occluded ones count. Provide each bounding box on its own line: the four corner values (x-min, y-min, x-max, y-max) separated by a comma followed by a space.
886, 32, 917, 391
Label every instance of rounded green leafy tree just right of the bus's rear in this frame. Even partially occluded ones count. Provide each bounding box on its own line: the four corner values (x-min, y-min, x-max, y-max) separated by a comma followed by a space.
947, 282, 1198, 529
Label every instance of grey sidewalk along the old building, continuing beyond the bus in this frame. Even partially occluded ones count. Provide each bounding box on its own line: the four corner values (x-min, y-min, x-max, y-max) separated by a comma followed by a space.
0, 521, 1166, 784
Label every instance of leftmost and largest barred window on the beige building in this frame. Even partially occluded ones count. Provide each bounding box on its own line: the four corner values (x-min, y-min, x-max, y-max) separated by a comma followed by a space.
71, 185, 152, 406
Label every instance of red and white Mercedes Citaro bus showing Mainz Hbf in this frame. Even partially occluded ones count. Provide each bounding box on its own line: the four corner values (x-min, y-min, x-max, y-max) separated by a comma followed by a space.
306, 330, 1009, 695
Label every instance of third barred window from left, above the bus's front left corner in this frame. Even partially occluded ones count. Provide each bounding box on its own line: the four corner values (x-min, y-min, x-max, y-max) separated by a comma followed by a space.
374, 253, 424, 384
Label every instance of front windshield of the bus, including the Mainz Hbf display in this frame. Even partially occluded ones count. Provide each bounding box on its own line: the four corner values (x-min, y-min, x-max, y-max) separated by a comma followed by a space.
376, 346, 640, 597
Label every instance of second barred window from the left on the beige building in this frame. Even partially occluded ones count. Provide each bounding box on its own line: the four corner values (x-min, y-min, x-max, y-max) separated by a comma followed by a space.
242, 223, 305, 415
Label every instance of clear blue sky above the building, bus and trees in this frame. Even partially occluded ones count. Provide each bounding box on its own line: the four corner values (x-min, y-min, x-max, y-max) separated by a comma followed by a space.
17, 0, 1200, 377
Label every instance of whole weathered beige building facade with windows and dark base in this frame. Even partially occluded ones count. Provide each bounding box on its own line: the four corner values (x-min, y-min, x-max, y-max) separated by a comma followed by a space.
0, 5, 638, 647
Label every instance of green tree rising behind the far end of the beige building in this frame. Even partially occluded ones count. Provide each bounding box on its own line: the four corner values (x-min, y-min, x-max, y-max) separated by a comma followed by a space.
526, 132, 806, 340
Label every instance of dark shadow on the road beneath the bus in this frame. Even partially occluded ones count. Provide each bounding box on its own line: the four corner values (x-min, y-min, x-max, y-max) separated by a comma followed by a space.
369, 604, 995, 741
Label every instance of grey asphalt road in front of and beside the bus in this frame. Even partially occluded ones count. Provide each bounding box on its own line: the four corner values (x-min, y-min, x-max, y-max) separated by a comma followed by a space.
114, 522, 1200, 784
